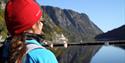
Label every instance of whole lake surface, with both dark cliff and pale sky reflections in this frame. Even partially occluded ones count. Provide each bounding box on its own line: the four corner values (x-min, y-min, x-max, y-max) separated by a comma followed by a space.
54, 46, 125, 63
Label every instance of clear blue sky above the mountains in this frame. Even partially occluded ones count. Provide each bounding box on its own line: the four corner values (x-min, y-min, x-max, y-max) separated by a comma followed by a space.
37, 0, 125, 32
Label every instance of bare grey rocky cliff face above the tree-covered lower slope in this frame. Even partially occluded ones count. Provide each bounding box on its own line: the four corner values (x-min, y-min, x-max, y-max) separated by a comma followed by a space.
44, 6, 102, 42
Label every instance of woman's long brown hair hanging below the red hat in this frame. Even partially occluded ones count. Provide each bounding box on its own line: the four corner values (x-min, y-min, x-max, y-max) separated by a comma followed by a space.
8, 34, 26, 63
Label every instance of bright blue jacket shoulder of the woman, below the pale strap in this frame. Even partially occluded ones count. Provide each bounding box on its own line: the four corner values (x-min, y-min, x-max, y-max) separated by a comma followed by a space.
27, 48, 58, 63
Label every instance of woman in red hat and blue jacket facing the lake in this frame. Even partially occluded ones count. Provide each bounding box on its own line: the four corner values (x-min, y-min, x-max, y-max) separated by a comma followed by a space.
5, 0, 58, 63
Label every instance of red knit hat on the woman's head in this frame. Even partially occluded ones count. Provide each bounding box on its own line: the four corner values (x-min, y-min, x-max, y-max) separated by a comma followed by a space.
5, 0, 42, 35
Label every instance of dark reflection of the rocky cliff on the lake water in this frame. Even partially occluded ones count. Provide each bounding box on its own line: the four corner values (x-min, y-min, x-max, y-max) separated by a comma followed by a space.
54, 46, 100, 63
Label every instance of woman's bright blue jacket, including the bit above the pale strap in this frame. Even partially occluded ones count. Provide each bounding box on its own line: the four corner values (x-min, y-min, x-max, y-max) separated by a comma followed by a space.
23, 40, 58, 63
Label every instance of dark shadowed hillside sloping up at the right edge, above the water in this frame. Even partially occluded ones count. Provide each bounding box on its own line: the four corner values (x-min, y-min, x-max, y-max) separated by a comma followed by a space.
96, 25, 125, 40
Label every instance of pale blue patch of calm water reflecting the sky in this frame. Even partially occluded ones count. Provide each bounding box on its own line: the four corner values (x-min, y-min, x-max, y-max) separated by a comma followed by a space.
91, 46, 125, 63
